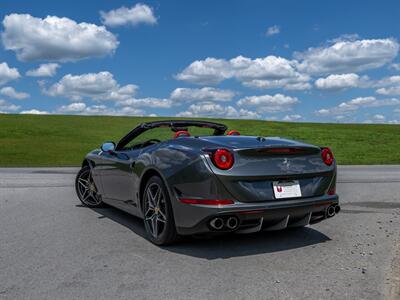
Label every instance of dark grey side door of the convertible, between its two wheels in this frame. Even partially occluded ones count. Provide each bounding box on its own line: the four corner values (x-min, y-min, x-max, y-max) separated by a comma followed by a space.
98, 149, 140, 211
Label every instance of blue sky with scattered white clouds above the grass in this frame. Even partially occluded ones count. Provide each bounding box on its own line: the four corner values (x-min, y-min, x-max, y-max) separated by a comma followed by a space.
0, 0, 400, 124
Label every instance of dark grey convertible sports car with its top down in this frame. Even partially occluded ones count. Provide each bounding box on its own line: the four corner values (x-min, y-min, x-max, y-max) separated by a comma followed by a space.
75, 120, 340, 245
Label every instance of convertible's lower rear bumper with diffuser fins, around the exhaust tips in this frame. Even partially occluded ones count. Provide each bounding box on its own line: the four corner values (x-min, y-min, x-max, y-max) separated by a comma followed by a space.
174, 195, 340, 235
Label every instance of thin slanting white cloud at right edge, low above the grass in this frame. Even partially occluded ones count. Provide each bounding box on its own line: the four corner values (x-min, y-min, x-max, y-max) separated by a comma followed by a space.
316, 96, 400, 116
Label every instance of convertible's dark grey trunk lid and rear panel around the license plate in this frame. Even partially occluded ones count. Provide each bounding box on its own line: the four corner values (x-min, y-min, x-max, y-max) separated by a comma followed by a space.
204, 136, 336, 202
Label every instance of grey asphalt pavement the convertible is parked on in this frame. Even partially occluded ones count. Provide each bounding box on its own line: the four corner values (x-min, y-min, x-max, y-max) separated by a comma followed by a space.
0, 166, 400, 300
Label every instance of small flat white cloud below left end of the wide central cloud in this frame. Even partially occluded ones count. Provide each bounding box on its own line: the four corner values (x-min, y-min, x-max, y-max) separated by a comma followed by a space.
170, 87, 235, 102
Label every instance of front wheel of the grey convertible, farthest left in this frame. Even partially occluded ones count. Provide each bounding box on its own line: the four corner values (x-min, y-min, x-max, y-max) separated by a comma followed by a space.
75, 166, 104, 208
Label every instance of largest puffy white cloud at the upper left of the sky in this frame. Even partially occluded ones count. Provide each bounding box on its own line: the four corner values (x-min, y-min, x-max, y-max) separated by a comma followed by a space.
1, 14, 119, 62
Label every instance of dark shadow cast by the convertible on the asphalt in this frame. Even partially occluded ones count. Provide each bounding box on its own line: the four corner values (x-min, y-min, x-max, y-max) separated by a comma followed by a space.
86, 207, 331, 260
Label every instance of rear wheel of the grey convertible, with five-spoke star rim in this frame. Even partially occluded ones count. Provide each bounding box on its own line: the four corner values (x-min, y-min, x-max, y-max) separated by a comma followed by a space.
142, 176, 178, 246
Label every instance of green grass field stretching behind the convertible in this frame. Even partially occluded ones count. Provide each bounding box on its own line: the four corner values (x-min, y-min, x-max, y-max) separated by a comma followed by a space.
0, 115, 400, 167
